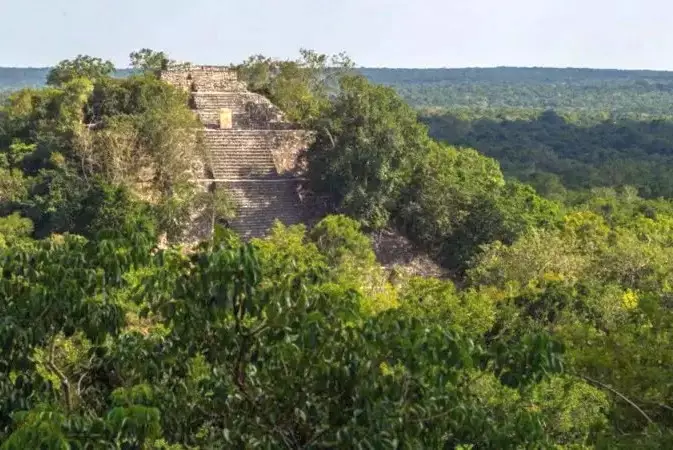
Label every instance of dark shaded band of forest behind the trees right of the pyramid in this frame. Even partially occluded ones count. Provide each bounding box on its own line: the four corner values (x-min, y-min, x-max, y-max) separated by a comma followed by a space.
422, 111, 673, 197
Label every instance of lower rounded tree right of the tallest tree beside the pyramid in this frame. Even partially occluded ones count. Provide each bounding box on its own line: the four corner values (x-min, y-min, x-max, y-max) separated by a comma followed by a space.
399, 145, 560, 271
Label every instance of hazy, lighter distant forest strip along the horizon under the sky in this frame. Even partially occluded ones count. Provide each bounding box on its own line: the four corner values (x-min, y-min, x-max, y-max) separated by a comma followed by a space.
6, 67, 673, 116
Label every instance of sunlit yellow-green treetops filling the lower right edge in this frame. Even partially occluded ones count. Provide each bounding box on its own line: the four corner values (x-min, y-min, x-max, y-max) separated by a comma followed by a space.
470, 191, 673, 442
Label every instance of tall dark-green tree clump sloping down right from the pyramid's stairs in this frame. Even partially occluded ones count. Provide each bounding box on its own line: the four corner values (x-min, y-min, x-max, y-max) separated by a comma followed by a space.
307, 77, 561, 273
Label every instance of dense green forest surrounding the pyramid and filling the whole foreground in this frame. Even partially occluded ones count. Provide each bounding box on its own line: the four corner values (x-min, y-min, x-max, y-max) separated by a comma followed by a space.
0, 49, 673, 450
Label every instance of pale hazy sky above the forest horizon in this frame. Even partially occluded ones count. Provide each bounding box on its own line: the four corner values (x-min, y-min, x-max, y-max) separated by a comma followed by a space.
0, 0, 673, 69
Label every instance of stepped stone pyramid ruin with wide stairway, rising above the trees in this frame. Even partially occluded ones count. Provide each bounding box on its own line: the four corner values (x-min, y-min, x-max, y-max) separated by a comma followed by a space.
162, 66, 309, 238
